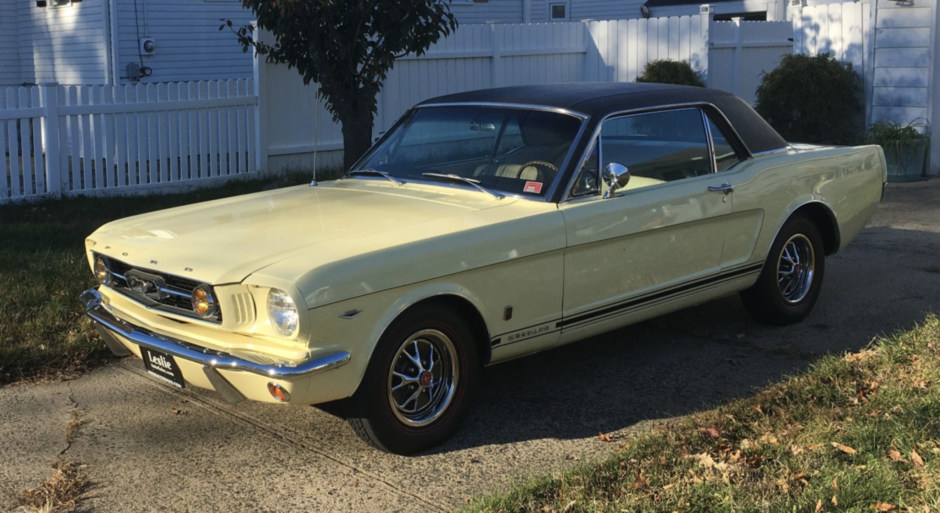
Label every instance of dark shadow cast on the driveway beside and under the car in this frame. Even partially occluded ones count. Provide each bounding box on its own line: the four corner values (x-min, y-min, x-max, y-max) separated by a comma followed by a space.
422, 227, 940, 453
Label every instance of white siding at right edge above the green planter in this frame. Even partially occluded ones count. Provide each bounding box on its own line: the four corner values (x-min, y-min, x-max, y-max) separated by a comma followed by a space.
871, 0, 935, 130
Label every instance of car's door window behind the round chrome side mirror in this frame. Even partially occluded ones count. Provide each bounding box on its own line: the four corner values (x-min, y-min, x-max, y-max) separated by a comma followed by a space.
601, 109, 712, 189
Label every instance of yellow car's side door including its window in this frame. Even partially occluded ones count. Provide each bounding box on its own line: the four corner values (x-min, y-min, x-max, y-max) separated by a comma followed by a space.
559, 108, 731, 336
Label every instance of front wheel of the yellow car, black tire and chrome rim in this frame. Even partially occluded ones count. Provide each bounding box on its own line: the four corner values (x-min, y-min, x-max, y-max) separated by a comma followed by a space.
346, 305, 480, 455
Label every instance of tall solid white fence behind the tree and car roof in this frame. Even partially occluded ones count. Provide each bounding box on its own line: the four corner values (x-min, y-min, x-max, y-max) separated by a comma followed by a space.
255, 15, 793, 171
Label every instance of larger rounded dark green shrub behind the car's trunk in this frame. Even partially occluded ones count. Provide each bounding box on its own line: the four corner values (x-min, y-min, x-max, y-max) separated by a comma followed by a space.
755, 53, 864, 144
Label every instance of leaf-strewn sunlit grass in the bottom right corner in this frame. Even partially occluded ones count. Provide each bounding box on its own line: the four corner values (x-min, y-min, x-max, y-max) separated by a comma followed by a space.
465, 317, 940, 513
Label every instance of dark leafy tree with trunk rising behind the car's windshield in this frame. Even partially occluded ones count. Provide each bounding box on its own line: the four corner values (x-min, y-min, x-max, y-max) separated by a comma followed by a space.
229, 0, 457, 169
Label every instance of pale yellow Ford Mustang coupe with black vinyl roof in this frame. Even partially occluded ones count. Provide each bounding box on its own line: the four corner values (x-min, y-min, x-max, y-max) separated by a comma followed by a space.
82, 84, 886, 454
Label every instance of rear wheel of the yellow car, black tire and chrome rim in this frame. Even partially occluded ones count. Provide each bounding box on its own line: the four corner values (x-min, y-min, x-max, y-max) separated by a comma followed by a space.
741, 216, 826, 326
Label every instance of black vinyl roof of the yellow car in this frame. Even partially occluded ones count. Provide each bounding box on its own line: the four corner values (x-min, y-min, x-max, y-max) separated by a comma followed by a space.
419, 82, 787, 154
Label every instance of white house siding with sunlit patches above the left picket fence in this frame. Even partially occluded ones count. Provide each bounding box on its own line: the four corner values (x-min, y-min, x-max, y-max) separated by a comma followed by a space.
16, 0, 108, 85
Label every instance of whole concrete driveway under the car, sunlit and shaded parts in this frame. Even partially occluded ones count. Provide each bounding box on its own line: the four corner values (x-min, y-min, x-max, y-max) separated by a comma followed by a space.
0, 180, 940, 512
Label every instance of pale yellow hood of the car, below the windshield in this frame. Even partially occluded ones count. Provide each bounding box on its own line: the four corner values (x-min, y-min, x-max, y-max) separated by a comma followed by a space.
88, 179, 548, 284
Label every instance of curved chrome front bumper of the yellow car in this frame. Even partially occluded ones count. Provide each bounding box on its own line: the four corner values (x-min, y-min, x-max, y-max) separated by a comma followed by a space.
79, 289, 352, 378
